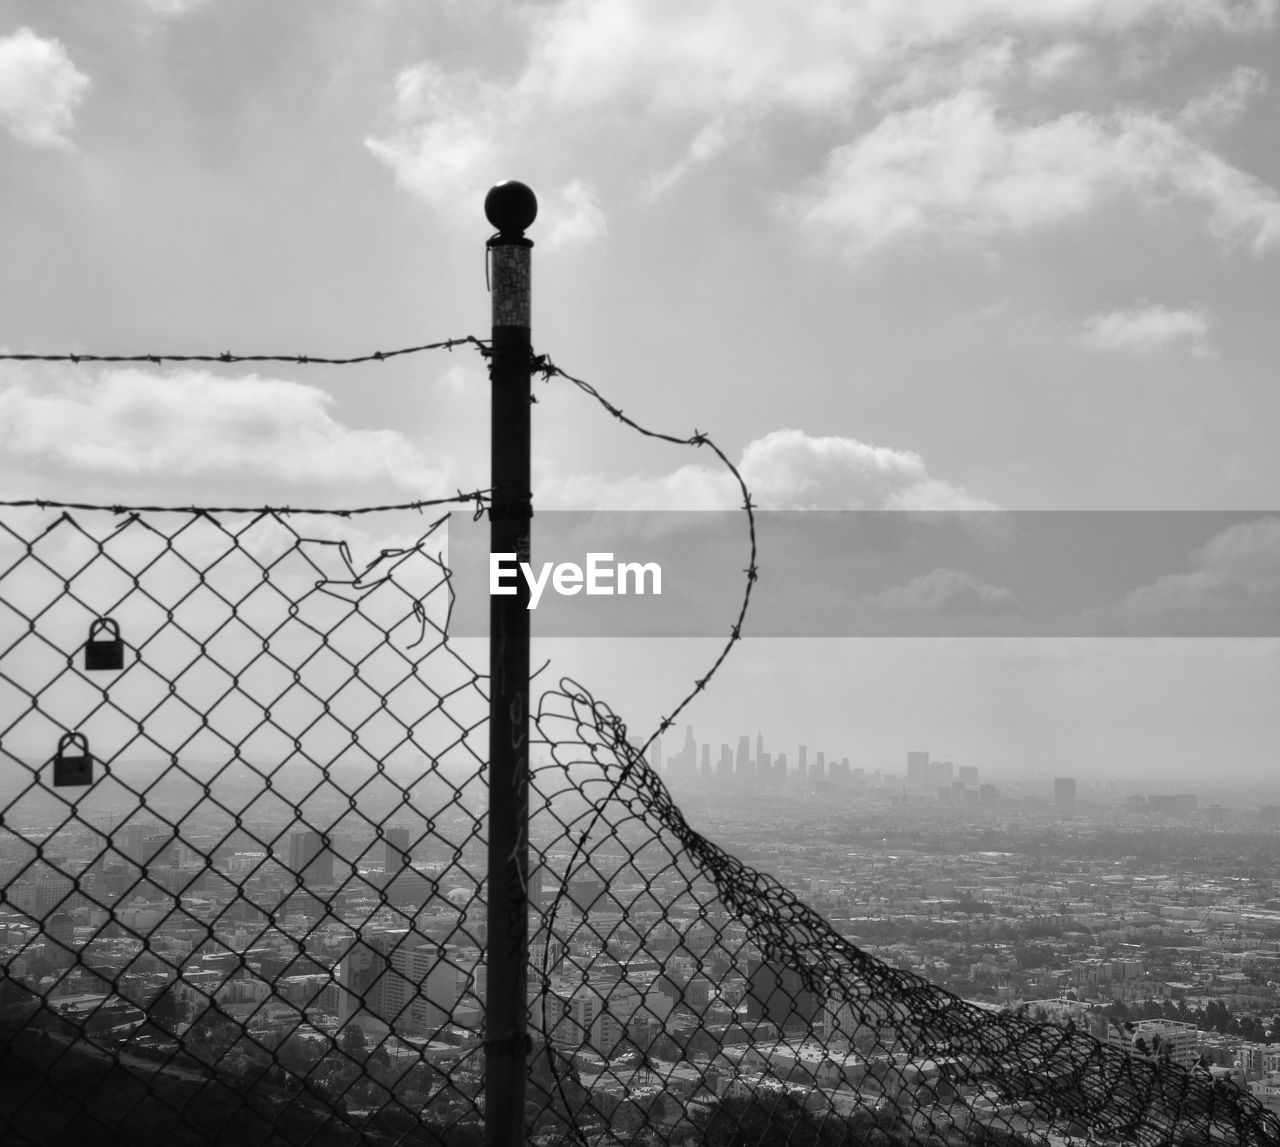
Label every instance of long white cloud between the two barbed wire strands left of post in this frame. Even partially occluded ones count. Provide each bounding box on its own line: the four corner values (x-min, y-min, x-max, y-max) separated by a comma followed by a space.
0, 369, 452, 502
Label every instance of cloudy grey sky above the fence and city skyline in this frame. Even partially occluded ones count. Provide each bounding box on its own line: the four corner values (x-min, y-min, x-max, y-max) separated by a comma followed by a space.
0, 0, 1280, 776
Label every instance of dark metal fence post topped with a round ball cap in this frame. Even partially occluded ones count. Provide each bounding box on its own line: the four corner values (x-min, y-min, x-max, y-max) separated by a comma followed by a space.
484, 180, 538, 1147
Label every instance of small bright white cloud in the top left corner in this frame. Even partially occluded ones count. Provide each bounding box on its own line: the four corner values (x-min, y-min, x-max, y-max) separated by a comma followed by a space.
0, 28, 90, 147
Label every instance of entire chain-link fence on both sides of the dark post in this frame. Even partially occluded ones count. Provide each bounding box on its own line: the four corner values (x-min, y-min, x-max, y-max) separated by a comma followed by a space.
0, 350, 1280, 1147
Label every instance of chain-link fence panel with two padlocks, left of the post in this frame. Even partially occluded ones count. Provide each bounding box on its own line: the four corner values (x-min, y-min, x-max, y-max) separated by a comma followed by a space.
0, 509, 488, 1143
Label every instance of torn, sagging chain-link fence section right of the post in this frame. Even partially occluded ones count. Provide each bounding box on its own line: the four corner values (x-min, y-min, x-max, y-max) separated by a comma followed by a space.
530, 680, 1280, 1147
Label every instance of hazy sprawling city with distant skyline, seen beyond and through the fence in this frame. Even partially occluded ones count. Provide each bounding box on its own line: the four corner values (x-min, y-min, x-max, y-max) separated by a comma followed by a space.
0, 728, 1280, 1127
